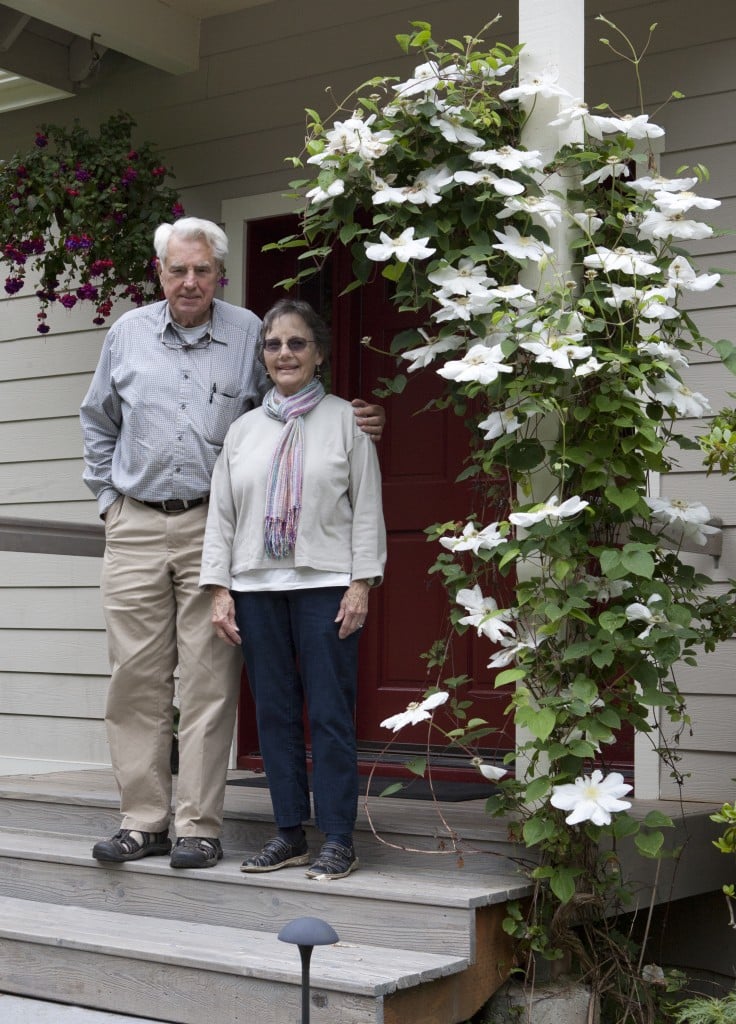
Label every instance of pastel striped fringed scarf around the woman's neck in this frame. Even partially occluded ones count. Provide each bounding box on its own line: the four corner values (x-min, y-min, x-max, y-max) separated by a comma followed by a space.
263, 380, 324, 558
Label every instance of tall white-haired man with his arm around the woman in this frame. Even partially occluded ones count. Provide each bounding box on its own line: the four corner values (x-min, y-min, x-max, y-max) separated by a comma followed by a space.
80, 217, 383, 867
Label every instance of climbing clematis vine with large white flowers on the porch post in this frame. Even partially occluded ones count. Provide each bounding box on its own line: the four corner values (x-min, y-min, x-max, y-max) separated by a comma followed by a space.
274, 23, 736, 983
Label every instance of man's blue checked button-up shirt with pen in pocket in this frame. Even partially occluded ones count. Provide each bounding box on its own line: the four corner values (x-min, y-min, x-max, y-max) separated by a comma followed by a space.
80, 299, 268, 515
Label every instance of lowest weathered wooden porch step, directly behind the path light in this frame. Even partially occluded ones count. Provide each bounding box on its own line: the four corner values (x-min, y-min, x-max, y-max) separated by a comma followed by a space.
0, 896, 468, 1024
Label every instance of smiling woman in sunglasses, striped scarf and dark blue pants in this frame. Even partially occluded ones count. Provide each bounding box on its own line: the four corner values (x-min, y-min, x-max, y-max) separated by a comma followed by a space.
200, 299, 386, 879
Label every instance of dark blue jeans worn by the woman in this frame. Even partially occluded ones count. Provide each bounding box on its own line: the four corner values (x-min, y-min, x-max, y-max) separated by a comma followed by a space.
232, 587, 359, 835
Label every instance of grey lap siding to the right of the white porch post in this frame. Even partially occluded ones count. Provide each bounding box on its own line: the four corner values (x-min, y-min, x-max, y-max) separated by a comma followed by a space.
588, 0, 736, 800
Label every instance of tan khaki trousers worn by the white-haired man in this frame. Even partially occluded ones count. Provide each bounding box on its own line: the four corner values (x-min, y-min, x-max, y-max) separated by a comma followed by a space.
102, 498, 242, 838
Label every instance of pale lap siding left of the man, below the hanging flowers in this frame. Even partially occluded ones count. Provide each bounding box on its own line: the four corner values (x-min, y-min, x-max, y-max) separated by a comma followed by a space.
0, 289, 110, 773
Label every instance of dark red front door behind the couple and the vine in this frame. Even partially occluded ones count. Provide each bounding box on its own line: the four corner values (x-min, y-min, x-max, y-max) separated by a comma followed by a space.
239, 217, 513, 774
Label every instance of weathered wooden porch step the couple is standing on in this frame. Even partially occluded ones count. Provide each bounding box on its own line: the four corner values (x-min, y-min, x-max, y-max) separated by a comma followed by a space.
0, 829, 529, 959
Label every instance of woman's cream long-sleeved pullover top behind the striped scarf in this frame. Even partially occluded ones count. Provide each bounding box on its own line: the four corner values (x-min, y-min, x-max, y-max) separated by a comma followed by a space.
200, 395, 386, 589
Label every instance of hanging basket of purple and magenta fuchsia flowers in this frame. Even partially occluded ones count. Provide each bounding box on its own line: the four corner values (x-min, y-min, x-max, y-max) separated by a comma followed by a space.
0, 113, 184, 334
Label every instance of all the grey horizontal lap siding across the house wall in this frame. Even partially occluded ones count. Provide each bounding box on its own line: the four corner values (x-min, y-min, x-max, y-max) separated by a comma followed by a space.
0, 0, 736, 797
